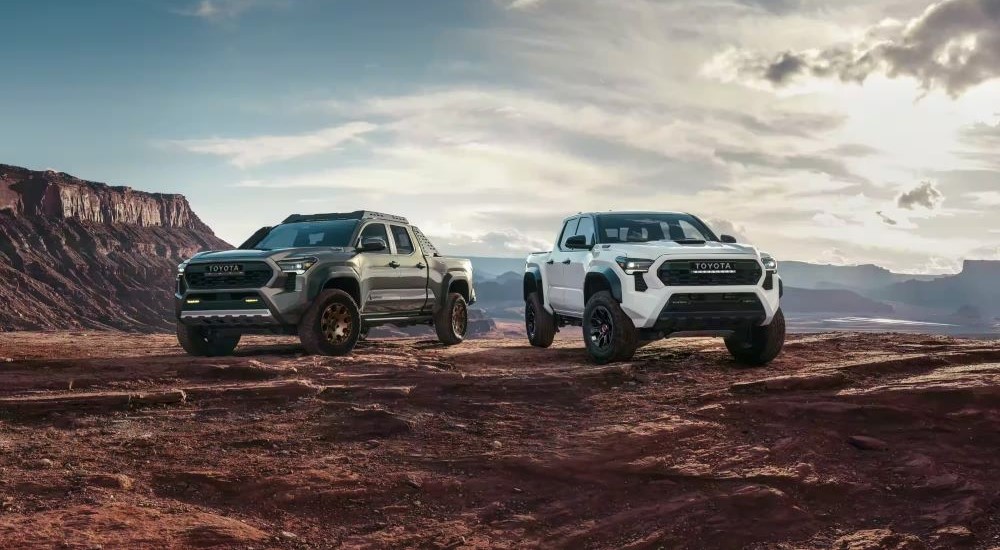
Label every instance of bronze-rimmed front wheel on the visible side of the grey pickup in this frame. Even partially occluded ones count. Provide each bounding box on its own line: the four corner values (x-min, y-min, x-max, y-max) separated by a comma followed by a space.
299, 290, 361, 355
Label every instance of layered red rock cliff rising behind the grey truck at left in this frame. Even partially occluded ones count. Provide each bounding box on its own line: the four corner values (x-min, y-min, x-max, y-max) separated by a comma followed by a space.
0, 164, 231, 331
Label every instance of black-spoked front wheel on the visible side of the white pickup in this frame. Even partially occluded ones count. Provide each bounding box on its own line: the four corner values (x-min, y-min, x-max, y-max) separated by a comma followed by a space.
583, 290, 639, 364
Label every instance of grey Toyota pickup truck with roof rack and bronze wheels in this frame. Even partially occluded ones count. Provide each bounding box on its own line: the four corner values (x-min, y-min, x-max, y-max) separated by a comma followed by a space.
175, 211, 476, 356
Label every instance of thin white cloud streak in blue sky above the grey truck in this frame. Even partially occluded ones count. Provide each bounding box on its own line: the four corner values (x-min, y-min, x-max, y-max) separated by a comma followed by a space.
167, 122, 378, 168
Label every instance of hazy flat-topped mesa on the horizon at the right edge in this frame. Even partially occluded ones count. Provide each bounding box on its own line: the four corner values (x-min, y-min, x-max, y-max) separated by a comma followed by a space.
875, 260, 1000, 316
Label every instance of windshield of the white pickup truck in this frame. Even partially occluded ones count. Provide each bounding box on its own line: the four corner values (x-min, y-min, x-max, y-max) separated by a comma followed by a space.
597, 213, 718, 244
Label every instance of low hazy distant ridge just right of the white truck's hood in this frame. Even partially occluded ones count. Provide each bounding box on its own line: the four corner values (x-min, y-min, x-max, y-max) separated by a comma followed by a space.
779, 261, 939, 291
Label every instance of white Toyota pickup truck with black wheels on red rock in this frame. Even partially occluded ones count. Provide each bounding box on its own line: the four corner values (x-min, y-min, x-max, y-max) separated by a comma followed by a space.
524, 212, 785, 365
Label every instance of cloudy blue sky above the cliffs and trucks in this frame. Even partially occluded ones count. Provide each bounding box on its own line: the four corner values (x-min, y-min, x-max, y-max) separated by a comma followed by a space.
0, 0, 1000, 273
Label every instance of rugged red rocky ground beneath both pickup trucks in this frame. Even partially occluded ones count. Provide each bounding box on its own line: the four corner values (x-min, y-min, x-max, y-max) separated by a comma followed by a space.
0, 332, 1000, 550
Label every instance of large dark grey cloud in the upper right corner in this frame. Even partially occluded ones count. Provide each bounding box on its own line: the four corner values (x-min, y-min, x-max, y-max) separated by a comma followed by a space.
723, 0, 1000, 96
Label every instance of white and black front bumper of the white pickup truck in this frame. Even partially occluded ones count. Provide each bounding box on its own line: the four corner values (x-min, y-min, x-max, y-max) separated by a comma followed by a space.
621, 256, 782, 333
